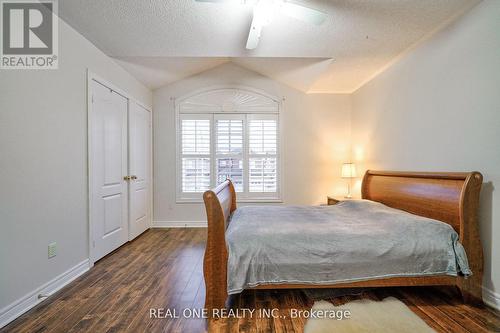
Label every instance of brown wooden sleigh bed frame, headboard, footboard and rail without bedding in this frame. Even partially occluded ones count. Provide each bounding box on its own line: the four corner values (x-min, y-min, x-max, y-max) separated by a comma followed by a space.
203, 170, 483, 313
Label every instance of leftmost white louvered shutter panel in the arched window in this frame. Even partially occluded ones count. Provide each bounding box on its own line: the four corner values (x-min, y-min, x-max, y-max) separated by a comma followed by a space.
181, 116, 211, 193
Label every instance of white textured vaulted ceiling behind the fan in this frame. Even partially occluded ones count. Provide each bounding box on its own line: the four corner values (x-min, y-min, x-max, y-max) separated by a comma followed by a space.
59, 0, 479, 92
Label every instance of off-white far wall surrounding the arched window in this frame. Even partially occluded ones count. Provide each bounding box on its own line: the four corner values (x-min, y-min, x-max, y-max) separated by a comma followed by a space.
153, 63, 350, 222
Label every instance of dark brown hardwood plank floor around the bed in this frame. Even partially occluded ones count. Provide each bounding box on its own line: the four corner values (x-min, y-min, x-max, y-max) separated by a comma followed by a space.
0, 229, 500, 332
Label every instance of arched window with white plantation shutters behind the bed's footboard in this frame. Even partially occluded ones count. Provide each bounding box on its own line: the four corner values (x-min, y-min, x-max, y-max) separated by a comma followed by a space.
176, 88, 281, 202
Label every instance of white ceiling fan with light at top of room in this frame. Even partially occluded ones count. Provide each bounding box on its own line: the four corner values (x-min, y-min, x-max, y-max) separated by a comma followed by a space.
195, 0, 326, 50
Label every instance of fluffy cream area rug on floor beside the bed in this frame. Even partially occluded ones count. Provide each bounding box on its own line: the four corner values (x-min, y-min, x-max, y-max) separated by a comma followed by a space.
304, 297, 435, 333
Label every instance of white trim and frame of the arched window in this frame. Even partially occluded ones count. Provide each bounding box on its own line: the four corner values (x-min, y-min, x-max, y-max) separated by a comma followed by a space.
172, 86, 284, 203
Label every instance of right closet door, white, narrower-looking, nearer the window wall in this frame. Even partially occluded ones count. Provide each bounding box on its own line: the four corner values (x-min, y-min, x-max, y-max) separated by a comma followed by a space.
129, 101, 151, 240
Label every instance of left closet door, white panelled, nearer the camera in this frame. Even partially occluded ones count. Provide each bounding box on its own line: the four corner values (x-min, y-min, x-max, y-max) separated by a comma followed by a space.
91, 80, 128, 261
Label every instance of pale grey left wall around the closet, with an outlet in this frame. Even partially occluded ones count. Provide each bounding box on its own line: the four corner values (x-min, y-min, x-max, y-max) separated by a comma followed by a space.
0, 20, 152, 309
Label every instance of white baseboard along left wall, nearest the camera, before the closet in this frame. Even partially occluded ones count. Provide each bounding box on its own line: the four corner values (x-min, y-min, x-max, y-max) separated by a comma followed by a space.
0, 259, 90, 328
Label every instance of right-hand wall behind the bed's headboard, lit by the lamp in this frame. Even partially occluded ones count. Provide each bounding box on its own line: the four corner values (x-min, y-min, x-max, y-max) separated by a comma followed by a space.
352, 0, 500, 302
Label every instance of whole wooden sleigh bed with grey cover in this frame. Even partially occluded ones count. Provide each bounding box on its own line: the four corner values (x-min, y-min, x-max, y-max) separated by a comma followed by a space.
203, 171, 483, 312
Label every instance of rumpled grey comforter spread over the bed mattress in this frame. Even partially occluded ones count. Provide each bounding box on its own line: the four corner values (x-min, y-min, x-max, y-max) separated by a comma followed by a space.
226, 200, 472, 294
